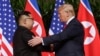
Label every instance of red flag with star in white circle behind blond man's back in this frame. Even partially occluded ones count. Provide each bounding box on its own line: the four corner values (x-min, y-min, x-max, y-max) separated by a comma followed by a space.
78, 0, 100, 56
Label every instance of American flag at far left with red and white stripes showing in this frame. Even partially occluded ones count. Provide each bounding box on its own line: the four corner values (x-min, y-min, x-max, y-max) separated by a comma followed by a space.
0, 0, 16, 56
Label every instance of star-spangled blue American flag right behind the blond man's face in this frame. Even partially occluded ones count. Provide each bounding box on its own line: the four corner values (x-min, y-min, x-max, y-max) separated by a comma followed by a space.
49, 0, 65, 35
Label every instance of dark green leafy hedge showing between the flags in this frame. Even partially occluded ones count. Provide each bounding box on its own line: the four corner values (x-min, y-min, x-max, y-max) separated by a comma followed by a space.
10, 0, 100, 32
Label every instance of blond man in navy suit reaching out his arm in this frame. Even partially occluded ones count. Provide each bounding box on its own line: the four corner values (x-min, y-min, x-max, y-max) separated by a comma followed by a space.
28, 4, 84, 56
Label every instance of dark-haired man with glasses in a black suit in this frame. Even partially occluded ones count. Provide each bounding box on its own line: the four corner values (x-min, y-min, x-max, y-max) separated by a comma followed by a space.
13, 11, 50, 56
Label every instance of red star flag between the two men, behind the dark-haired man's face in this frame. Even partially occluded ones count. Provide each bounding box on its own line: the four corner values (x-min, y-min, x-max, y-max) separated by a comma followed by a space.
25, 0, 51, 56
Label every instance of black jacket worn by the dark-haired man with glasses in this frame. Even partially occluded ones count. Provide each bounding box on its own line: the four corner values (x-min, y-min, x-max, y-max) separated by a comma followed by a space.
13, 26, 50, 56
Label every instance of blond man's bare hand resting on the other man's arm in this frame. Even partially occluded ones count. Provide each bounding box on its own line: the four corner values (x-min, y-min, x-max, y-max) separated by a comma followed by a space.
28, 36, 43, 47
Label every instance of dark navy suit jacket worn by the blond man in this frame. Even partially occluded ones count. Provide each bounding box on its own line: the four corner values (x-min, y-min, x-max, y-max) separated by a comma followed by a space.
43, 18, 84, 56
